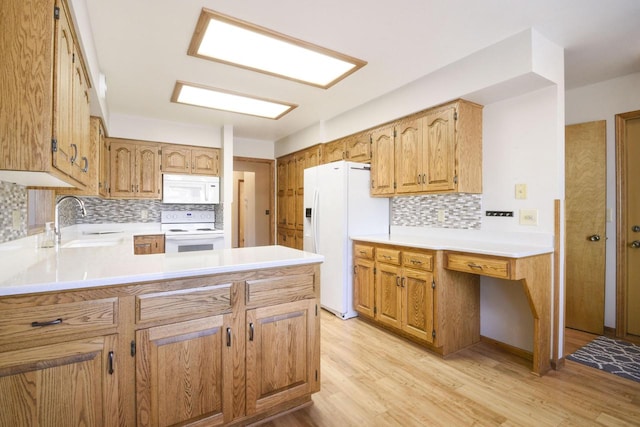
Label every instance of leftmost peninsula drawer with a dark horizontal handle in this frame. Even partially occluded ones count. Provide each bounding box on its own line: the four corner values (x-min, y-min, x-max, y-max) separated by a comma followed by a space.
0, 298, 118, 344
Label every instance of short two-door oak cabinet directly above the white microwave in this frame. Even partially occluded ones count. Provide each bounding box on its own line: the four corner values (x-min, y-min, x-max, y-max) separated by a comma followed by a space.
162, 144, 220, 176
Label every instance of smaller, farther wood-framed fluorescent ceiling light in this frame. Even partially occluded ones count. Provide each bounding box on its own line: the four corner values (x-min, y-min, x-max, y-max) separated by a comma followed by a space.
171, 81, 297, 119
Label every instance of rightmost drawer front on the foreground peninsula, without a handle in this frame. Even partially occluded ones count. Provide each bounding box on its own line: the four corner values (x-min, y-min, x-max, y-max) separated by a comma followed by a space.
245, 274, 316, 306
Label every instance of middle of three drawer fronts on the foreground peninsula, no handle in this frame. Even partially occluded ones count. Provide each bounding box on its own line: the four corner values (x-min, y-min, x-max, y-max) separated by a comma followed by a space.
136, 283, 231, 323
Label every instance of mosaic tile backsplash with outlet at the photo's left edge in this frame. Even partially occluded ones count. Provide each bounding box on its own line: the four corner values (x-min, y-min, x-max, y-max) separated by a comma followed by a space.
0, 181, 27, 243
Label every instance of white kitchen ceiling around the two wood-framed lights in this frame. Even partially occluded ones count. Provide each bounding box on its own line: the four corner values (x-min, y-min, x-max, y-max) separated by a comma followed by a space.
86, 0, 640, 140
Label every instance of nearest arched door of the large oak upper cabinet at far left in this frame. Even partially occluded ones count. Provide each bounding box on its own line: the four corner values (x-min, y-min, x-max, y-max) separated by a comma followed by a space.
53, 1, 74, 175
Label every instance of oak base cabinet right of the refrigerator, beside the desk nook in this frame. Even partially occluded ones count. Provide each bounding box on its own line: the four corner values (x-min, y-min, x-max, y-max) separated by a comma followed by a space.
353, 241, 480, 355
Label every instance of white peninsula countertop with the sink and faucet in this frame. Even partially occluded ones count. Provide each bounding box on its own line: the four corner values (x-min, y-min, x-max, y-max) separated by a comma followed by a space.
0, 224, 324, 296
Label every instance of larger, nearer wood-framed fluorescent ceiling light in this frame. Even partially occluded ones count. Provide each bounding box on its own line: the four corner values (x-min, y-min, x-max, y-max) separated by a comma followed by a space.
188, 9, 366, 89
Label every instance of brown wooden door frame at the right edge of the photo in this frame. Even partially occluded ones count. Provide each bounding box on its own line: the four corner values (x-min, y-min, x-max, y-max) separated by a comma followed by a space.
615, 110, 640, 339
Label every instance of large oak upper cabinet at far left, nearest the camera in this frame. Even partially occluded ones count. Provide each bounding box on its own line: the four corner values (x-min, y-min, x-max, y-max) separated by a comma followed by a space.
0, 0, 91, 186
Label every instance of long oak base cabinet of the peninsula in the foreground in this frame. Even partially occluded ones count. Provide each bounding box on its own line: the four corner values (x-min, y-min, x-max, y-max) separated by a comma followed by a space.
0, 264, 320, 427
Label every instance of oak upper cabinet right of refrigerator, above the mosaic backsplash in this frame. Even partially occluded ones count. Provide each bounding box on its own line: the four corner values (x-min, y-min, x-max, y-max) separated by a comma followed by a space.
371, 100, 482, 196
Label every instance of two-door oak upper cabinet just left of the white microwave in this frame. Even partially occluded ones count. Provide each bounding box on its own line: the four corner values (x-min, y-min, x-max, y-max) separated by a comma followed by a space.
109, 138, 160, 199
